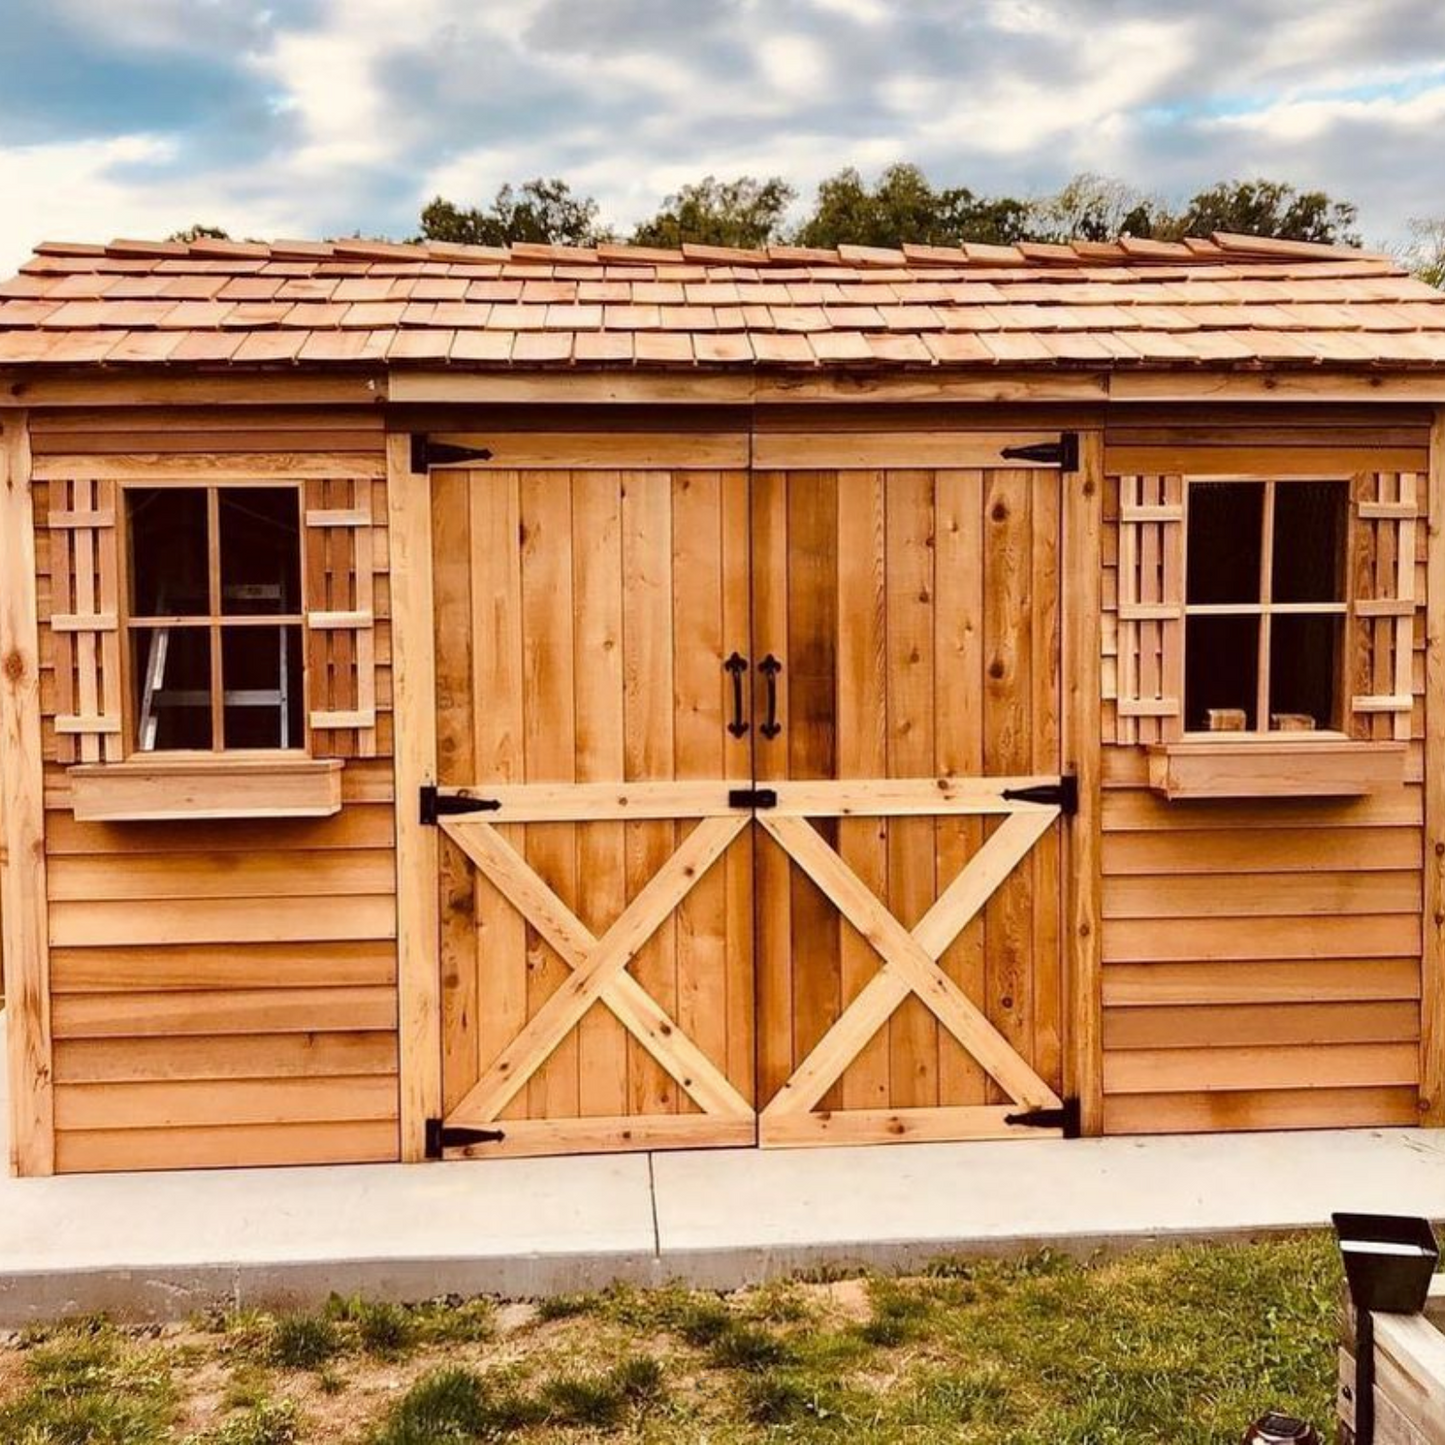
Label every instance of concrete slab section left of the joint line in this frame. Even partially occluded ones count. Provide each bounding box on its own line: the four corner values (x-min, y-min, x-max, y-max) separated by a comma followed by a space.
0, 1016, 657, 1327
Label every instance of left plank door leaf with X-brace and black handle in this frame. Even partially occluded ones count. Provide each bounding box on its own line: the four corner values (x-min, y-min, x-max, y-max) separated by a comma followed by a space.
431, 467, 756, 1157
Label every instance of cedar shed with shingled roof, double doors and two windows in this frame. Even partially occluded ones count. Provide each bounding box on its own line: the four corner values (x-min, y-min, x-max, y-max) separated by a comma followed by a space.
0, 234, 1445, 1175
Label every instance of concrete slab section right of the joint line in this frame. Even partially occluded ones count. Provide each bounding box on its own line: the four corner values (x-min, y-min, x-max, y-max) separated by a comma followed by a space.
653, 1129, 1445, 1286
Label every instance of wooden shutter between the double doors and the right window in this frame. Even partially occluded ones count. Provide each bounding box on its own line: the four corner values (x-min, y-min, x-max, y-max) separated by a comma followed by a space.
1114, 475, 1183, 743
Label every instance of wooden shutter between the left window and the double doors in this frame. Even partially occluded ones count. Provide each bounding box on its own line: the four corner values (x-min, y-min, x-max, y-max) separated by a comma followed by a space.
305, 477, 377, 757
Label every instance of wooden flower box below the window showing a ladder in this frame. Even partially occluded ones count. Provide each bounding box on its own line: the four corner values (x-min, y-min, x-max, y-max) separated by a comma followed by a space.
66, 754, 345, 822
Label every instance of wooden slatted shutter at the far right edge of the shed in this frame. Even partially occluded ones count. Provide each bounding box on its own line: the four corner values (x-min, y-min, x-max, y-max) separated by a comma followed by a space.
1350, 471, 1420, 741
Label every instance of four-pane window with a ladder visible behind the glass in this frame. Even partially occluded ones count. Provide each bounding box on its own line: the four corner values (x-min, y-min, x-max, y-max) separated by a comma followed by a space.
124, 486, 305, 753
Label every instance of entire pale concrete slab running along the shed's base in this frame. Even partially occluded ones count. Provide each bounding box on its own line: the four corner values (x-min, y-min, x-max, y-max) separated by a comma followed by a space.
0, 1016, 1445, 1328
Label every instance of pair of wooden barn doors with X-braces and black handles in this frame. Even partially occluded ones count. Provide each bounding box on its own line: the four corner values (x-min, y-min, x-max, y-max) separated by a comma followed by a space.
431, 450, 1064, 1156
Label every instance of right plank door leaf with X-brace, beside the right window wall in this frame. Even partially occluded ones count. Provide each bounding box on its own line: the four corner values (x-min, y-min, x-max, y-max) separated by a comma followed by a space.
753, 467, 1065, 1146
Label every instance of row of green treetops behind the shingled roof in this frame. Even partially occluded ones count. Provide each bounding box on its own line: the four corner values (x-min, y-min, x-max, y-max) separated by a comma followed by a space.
419, 163, 1360, 247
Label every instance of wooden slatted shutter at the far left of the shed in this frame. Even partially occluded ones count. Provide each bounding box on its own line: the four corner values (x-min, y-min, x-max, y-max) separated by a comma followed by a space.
48, 477, 123, 763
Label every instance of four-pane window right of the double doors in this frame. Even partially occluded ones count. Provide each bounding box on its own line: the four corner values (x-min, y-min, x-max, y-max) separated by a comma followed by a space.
1183, 480, 1350, 733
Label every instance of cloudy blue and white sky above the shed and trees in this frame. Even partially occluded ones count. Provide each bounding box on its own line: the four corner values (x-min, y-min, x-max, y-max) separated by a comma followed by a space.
0, 0, 1445, 269
